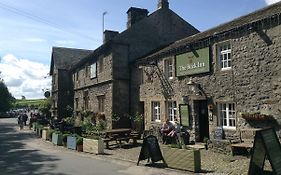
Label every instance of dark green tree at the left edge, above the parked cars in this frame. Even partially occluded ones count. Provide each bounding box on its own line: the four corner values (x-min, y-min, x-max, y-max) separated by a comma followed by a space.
0, 80, 15, 112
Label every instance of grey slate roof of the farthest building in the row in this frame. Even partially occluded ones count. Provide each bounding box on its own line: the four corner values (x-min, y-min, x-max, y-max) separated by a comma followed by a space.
50, 47, 93, 75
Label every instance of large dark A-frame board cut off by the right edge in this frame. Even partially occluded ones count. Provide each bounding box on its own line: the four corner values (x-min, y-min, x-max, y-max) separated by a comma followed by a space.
248, 128, 281, 175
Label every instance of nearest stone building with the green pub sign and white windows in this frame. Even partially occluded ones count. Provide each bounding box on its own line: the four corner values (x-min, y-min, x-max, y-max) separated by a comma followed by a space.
131, 2, 281, 141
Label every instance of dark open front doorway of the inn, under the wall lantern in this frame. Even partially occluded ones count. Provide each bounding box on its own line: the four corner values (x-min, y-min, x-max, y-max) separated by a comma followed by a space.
194, 100, 209, 142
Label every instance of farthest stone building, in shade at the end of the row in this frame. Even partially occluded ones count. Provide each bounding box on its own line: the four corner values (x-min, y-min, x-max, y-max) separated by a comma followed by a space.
49, 47, 91, 118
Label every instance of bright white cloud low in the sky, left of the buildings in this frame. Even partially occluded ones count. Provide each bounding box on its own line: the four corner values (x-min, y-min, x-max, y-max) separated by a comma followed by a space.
0, 54, 51, 99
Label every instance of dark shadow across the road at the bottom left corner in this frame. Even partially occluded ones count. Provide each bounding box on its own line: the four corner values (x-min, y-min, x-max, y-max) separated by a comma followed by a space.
0, 121, 65, 175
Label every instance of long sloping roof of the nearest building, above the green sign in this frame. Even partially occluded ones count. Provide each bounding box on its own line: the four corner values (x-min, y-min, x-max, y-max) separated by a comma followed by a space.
138, 2, 281, 62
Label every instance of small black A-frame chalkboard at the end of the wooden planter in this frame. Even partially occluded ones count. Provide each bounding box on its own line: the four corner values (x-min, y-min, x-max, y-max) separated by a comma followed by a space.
137, 135, 166, 165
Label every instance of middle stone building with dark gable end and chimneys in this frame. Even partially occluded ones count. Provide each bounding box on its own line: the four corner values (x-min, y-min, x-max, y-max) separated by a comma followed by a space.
71, 0, 199, 127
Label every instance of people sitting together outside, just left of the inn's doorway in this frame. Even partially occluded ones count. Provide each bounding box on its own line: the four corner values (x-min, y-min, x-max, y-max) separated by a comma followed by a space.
160, 119, 182, 144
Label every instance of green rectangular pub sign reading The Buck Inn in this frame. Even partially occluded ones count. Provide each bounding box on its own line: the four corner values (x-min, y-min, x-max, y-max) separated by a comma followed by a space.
176, 47, 210, 77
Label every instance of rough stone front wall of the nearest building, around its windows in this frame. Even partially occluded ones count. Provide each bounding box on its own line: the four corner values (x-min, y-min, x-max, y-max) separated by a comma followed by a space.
132, 25, 281, 140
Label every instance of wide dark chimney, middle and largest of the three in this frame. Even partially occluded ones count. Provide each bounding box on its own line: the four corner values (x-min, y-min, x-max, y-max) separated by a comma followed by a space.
127, 7, 148, 28
